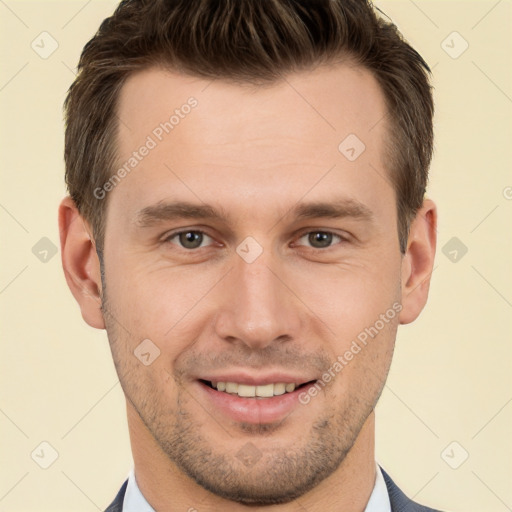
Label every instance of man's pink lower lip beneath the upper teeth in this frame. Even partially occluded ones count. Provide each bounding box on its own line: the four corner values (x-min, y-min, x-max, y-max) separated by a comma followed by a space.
197, 381, 315, 424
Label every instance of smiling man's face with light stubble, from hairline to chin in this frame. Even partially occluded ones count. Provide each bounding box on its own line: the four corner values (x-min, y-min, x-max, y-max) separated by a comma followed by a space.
97, 64, 402, 505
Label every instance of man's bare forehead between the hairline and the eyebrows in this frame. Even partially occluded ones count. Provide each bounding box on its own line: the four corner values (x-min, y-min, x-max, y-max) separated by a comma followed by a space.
111, 63, 387, 224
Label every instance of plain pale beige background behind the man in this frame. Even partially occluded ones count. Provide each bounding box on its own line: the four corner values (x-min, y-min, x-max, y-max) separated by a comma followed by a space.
0, 0, 512, 512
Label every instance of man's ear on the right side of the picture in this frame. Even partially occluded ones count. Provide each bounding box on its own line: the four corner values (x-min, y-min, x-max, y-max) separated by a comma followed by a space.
400, 199, 437, 324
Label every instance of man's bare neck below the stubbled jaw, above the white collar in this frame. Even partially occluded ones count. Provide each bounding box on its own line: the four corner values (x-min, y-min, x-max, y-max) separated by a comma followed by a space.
127, 402, 376, 512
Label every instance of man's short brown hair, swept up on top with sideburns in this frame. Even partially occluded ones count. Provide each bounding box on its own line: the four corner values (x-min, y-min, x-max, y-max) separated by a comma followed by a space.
64, 0, 434, 253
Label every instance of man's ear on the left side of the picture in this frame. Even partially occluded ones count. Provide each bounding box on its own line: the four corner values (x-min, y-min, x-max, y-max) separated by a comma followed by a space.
59, 196, 105, 329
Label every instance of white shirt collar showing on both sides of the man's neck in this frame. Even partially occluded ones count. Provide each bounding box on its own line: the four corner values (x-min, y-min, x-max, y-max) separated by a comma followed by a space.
123, 464, 391, 512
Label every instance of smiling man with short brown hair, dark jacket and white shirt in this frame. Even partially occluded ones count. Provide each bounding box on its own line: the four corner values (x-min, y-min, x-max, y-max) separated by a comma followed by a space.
59, 0, 444, 512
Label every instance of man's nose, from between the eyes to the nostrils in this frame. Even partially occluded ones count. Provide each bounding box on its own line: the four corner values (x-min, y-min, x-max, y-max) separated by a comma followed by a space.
215, 245, 304, 350
